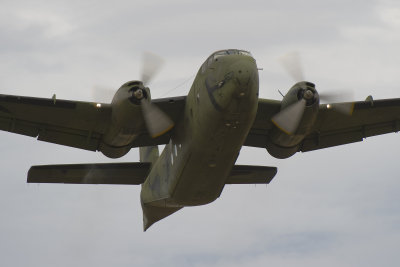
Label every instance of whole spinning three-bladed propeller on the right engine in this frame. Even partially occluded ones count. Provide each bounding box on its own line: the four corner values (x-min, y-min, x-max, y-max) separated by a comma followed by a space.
272, 51, 354, 134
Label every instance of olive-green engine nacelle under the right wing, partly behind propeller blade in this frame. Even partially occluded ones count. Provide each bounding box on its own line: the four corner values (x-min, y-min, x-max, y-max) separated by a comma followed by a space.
266, 82, 319, 158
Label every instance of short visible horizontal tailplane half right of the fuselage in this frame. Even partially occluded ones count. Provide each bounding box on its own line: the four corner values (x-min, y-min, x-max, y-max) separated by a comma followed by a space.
226, 165, 277, 184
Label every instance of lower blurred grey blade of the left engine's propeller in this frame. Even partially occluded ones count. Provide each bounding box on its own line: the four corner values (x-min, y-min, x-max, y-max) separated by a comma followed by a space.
141, 98, 174, 138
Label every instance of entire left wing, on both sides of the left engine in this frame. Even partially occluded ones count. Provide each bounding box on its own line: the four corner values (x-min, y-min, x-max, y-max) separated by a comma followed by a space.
0, 95, 185, 151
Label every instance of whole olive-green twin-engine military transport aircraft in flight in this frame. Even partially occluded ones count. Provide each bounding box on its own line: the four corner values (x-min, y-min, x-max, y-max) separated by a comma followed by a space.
0, 49, 400, 230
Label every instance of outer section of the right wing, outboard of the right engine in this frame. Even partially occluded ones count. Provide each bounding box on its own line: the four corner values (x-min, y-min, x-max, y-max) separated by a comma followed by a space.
300, 98, 400, 152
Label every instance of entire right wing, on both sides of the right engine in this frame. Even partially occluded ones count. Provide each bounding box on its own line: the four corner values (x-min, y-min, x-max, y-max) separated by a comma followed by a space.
244, 99, 400, 152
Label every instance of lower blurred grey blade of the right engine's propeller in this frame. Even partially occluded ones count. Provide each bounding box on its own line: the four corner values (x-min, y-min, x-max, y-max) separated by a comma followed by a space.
272, 99, 307, 135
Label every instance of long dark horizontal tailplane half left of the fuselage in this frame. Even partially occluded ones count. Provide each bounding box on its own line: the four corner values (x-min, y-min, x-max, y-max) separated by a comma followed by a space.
28, 162, 151, 185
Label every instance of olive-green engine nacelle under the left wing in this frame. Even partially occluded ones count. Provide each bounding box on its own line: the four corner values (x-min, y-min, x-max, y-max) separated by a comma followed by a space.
100, 81, 150, 158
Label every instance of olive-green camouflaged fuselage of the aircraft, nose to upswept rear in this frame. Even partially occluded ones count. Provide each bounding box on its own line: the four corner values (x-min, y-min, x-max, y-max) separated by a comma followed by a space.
141, 50, 259, 226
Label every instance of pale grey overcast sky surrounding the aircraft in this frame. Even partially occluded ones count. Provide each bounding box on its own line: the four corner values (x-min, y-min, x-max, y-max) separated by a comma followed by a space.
0, 0, 400, 267
